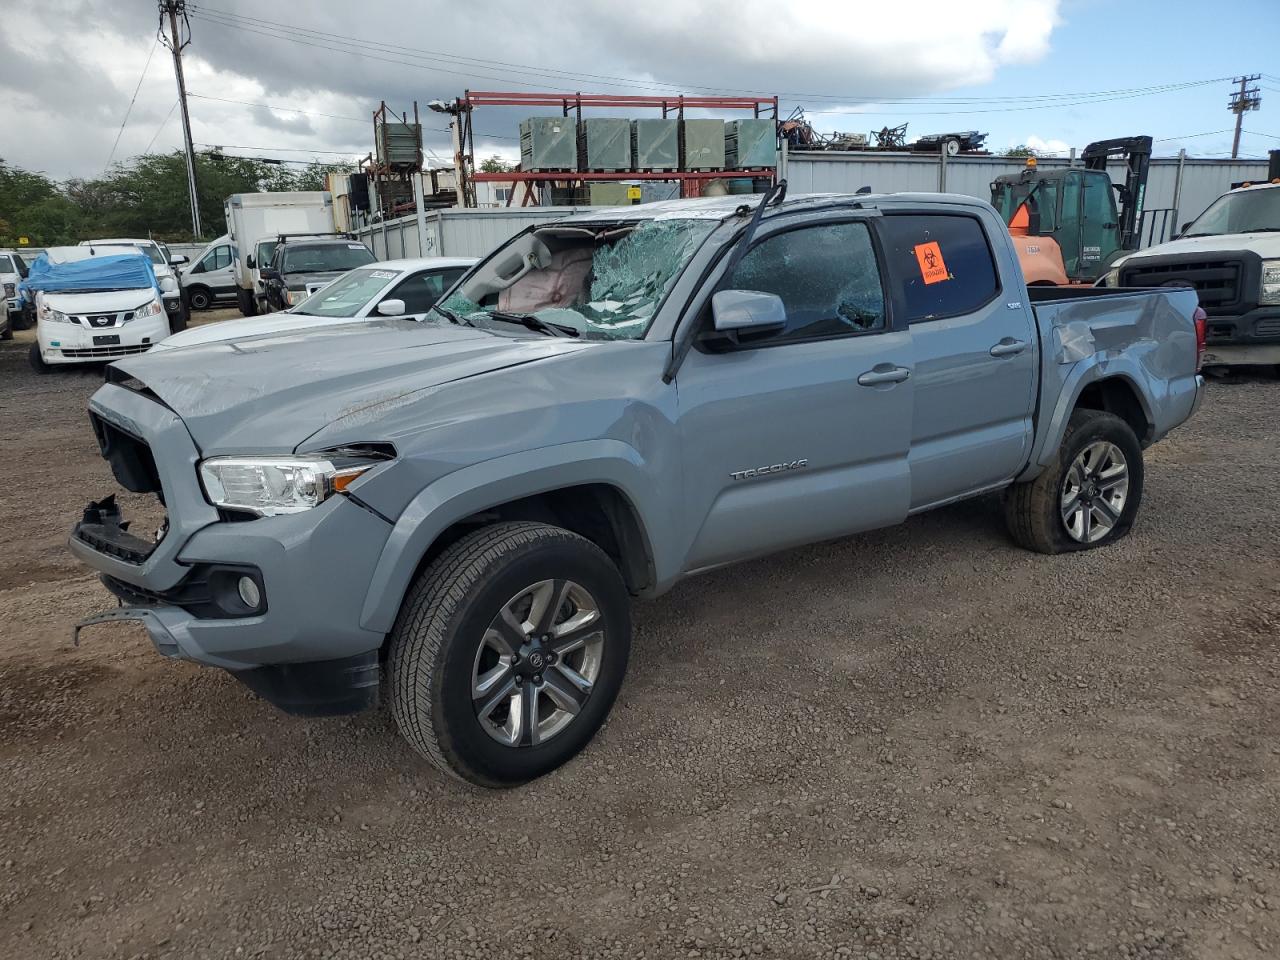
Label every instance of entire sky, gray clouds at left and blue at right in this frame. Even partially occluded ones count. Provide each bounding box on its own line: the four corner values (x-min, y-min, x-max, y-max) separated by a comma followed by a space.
0, 0, 1280, 179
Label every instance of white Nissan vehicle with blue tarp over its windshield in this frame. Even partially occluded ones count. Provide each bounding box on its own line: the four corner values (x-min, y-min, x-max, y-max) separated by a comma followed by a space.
23, 244, 173, 374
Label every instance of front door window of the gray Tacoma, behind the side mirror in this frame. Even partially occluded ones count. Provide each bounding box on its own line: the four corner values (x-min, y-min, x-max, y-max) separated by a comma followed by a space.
724, 221, 886, 344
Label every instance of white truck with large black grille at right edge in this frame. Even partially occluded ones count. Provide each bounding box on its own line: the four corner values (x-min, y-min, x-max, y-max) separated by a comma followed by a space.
1101, 183, 1280, 365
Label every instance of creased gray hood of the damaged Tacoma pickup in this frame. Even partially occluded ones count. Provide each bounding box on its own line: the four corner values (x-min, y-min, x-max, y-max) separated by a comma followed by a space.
113, 320, 590, 457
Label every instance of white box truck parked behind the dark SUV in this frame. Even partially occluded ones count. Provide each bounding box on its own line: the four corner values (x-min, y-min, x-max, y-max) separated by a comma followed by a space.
224, 191, 334, 316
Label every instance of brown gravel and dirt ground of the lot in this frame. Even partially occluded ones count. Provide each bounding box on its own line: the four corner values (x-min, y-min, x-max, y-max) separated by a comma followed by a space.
0, 317, 1280, 960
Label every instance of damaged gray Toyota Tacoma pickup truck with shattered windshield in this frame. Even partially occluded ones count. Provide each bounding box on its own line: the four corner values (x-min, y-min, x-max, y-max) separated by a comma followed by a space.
70, 189, 1203, 786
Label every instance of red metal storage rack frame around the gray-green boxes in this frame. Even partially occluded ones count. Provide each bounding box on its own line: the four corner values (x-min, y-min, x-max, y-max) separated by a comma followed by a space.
455, 90, 778, 206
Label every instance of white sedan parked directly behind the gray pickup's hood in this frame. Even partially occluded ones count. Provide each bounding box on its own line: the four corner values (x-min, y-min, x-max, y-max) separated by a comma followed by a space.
155, 257, 476, 349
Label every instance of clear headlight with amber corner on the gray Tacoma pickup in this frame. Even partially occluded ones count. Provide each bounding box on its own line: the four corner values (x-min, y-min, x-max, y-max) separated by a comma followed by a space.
200, 456, 385, 517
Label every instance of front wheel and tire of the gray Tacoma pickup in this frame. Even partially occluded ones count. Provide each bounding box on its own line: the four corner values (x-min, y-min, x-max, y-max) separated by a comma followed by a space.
387, 522, 631, 787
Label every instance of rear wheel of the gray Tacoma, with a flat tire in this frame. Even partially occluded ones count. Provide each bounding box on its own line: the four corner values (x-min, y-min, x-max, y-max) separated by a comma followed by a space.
1005, 410, 1143, 553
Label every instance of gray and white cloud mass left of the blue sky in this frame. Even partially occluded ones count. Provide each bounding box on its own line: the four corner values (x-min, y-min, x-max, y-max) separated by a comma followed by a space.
0, 0, 1060, 178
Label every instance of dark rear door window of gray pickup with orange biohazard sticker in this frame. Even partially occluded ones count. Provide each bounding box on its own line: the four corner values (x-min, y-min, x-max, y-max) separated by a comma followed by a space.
879, 214, 1000, 324
